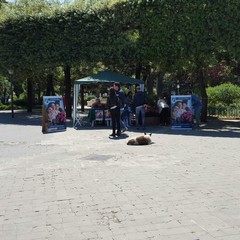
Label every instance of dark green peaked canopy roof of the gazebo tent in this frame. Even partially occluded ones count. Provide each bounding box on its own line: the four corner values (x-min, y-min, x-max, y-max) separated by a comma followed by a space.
74, 70, 144, 85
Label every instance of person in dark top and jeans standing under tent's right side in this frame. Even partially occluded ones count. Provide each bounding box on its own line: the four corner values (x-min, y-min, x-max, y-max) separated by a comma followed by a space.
133, 86, 147, 130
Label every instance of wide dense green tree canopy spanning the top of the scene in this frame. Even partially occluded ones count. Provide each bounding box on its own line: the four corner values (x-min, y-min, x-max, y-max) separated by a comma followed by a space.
0, 0, 240, 119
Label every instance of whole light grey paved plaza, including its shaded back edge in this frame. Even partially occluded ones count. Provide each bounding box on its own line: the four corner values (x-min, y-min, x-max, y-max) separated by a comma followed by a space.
0, 113, 240, 240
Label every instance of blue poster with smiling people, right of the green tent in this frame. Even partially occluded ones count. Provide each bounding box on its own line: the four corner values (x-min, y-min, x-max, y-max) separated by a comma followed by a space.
171, 95, 193, 130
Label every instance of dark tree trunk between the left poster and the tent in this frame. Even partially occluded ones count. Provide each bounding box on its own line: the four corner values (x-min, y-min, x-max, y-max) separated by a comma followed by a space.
64, 65, 72, 118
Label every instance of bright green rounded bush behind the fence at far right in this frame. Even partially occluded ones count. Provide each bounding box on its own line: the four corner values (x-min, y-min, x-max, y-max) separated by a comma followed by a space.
207, 83, 240, 107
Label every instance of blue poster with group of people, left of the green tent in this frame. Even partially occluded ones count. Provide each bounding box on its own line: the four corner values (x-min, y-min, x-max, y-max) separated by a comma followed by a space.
42, 96, 67, 133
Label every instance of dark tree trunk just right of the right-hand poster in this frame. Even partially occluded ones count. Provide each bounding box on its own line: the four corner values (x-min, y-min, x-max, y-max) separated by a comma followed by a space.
197, 64, 208, 122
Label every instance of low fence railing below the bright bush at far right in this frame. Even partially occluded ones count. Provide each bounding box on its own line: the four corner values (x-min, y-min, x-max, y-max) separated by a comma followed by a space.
208, 107, 240, 118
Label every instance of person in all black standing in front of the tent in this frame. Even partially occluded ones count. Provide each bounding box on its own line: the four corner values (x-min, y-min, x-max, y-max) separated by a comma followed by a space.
107, 87, 121, 137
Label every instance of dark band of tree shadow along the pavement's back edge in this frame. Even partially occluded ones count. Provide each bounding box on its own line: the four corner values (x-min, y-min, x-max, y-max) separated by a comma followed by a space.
0, 109, 240, 140
